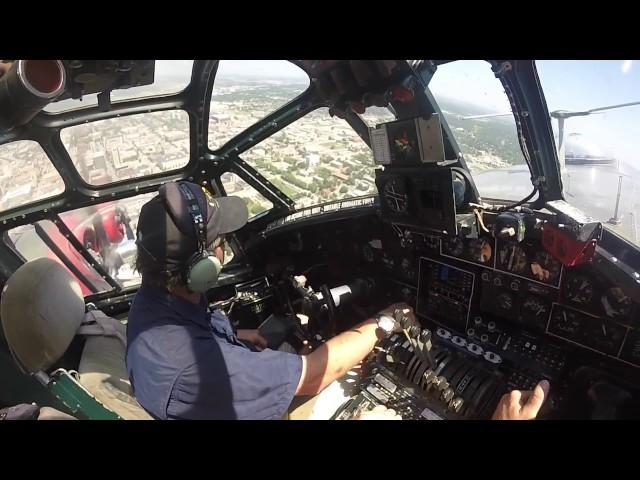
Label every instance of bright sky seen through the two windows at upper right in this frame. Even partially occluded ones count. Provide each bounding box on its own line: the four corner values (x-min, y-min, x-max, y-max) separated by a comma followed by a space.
429, 60, 640, 169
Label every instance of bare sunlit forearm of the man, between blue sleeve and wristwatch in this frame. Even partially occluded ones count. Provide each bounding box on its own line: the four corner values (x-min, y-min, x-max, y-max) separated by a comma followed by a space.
296, 320, 378, 395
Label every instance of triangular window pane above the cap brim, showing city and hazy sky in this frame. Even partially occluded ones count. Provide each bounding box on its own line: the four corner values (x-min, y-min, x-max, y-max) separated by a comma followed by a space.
208, 60, 309, 150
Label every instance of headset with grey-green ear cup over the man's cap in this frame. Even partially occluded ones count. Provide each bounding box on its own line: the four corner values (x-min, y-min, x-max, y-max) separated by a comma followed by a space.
178, 183, 222, 293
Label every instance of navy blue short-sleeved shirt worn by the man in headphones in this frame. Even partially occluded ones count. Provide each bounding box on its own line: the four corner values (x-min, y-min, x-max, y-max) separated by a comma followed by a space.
126, 285, 302, 419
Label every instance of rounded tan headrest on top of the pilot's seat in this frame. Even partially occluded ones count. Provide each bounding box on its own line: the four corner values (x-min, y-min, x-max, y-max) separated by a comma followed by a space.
0, 258, 85, 373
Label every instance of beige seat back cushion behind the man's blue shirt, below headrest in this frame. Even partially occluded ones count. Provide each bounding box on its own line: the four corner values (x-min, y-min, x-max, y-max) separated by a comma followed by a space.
78, 336, 152, 420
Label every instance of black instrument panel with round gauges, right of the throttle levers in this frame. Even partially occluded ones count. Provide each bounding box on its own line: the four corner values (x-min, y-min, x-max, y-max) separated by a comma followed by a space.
385, 221, 640, 367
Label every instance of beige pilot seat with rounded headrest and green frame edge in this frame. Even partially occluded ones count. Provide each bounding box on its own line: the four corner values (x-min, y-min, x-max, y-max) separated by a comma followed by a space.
0, 258, 152, 420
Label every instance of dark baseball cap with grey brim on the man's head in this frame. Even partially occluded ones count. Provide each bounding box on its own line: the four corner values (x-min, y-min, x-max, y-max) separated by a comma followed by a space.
137, 182, 249, 270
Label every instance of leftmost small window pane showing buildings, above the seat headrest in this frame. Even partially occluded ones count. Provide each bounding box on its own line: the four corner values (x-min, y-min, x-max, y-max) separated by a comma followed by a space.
0, 140, 64, 211
